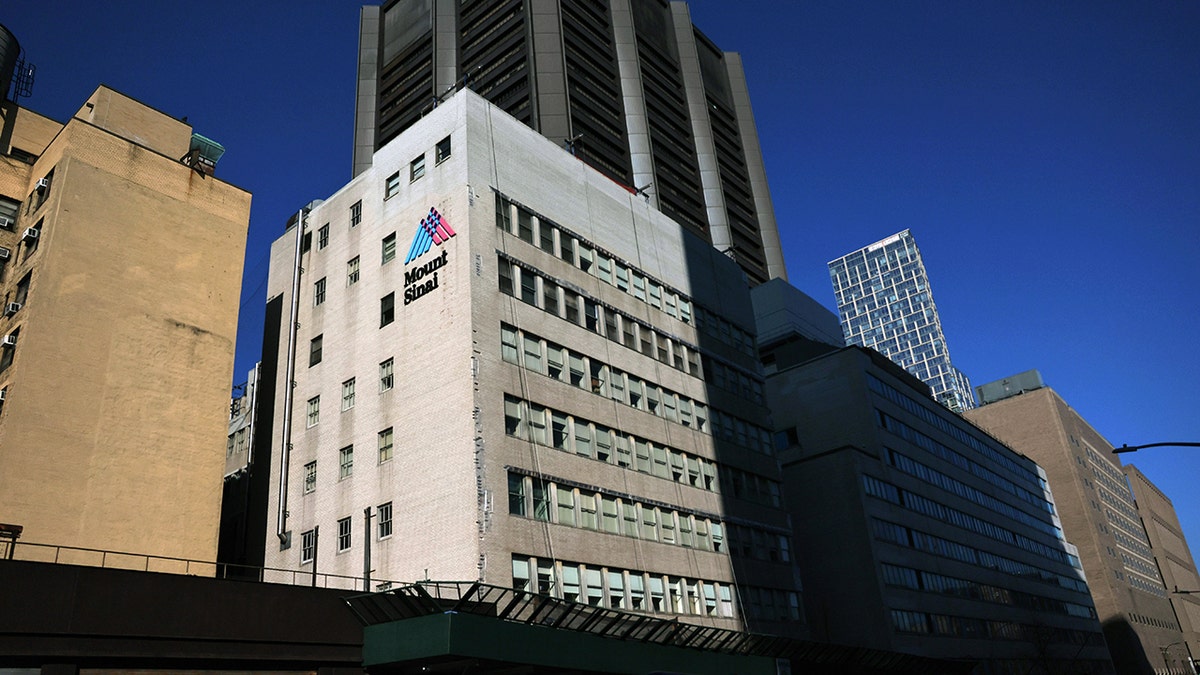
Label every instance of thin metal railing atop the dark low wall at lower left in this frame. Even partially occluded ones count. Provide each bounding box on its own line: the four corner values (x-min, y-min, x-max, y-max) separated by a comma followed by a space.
0, 542, 402, 592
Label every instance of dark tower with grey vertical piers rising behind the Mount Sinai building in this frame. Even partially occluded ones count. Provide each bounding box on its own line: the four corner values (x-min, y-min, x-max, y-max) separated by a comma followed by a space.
354, 0, 787, 285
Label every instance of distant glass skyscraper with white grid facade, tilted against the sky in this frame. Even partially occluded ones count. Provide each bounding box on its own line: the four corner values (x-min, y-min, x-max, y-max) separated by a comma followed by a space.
829, 229, 976, 412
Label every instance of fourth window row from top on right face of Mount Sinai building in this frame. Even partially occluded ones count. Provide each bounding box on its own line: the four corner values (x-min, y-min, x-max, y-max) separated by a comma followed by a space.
504, 395, 781, 507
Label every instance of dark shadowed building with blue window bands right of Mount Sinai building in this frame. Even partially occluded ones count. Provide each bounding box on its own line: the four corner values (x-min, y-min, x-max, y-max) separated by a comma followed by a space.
754, 282, 1114, 674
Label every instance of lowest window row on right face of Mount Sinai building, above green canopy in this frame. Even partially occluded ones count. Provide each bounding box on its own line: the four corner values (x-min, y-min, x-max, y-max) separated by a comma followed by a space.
512, 554, 800, 621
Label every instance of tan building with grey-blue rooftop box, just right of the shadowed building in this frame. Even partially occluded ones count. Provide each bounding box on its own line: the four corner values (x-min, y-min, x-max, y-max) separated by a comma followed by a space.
967, 371, 1187, 674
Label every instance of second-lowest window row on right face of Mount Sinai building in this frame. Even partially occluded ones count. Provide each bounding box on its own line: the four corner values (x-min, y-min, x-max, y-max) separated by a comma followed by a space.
509, 471, 792, 562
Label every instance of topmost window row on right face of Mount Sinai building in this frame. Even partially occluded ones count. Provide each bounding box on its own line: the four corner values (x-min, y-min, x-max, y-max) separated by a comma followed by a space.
496, 195, 755, 358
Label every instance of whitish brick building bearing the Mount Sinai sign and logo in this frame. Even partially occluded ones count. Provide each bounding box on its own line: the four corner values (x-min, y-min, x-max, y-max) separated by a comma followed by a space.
251, 90, 803, 635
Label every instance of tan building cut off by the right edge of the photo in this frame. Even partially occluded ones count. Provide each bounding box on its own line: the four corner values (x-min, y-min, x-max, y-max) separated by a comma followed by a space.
1121, 464, 1200, 673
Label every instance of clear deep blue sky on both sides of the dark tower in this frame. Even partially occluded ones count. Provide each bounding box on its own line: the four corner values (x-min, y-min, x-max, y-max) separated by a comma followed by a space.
9, 0, 1200, 557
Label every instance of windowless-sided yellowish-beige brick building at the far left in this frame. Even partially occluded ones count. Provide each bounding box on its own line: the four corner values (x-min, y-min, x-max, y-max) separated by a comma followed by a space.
0, 86, 250, 572
